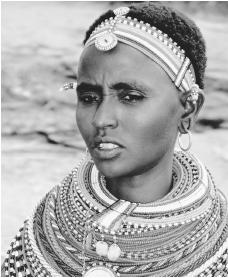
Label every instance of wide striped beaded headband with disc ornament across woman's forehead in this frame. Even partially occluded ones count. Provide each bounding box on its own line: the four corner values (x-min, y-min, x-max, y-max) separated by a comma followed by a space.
85, 7, 199, 95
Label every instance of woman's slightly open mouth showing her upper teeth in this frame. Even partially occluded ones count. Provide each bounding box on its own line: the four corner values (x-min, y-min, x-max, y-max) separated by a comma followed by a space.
93, 140, 123, 160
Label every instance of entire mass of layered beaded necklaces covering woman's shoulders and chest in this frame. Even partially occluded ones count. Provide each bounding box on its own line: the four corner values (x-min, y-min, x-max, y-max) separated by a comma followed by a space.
2, 152, 228, 277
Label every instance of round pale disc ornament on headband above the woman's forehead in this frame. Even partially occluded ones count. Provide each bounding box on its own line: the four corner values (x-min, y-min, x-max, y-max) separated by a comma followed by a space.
95, 32, 118, 51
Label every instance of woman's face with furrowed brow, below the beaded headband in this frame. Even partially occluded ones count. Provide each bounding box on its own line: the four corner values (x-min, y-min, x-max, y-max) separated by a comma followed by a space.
76, 43, 183, 178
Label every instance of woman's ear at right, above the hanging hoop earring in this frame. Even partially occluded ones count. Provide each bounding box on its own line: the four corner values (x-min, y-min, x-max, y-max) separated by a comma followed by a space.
178, 90, 204, 134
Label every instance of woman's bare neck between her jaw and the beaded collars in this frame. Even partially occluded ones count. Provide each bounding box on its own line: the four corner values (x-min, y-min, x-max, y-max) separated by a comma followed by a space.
107, 151, 173, 203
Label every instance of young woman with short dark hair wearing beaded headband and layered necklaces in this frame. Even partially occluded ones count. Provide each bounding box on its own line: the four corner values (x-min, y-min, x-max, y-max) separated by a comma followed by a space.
3, 2, 228, 277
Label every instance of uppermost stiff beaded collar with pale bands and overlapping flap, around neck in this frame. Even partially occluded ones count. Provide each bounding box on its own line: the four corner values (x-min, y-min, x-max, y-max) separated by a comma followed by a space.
72, 152, 215, 233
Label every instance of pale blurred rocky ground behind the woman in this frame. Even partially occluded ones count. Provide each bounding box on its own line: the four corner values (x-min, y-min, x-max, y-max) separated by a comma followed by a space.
1, 2, 228, 256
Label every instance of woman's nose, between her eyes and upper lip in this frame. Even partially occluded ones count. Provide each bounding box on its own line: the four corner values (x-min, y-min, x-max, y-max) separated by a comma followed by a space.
92, 96, 118, 130
